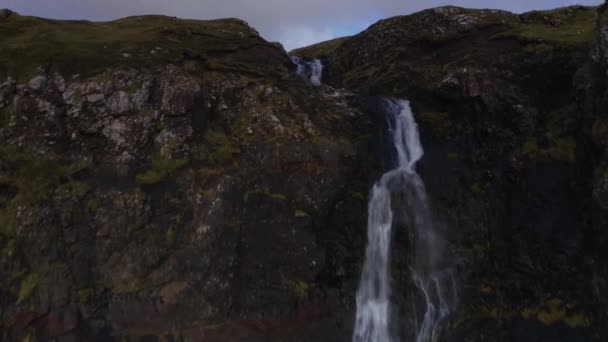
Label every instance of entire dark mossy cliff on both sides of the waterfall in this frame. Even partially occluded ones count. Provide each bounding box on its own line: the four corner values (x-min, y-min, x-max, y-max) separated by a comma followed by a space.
0, 3, 608, 341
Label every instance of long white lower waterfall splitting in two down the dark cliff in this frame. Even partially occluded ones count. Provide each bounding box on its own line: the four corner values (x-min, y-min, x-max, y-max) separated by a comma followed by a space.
353, 99, 457, 342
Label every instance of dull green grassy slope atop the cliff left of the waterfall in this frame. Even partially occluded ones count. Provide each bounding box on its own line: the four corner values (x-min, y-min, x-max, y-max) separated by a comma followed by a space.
0, 10, 262, 80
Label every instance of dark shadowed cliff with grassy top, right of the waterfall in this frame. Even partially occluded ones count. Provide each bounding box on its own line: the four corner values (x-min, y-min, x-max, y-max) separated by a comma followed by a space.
298, 6, 608, 341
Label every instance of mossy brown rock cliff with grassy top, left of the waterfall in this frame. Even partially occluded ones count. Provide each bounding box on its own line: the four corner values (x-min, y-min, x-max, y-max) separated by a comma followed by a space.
0, 12, 375, 341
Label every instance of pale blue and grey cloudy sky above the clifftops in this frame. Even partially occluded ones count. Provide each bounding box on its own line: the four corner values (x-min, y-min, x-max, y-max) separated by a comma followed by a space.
0, 0, 604, 50
